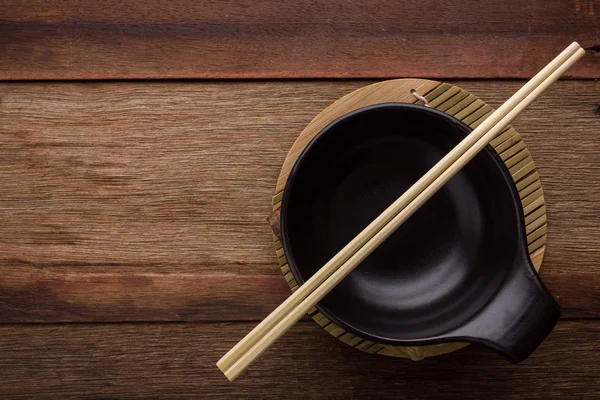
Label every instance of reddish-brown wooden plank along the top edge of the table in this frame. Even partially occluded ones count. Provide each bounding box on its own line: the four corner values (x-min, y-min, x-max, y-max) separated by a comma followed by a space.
0, 0, 600, 79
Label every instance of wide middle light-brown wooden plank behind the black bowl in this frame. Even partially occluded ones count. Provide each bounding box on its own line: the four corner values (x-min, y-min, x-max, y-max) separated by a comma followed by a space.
0, 81, 600, 322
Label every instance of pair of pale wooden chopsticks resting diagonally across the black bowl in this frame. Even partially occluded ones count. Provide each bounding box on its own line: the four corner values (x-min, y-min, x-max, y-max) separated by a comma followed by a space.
217, 42, 585, 381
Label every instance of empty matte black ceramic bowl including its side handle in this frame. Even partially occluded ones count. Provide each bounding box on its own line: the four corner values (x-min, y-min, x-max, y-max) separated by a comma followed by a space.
281, 103, 560, 362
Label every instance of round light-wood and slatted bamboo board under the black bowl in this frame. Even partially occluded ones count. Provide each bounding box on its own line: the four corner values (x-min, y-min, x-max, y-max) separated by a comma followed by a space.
270, 79, 546, 360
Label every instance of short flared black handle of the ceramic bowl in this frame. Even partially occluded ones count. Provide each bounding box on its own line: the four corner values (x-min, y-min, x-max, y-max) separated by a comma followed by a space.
453, 255, 560, 363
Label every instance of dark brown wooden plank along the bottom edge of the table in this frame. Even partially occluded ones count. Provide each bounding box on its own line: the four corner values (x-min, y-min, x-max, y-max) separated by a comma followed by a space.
0, 321, 600, 400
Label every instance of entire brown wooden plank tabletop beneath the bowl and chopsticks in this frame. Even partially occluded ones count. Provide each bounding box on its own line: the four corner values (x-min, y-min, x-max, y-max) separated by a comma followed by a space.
0, 0, 600, 399
